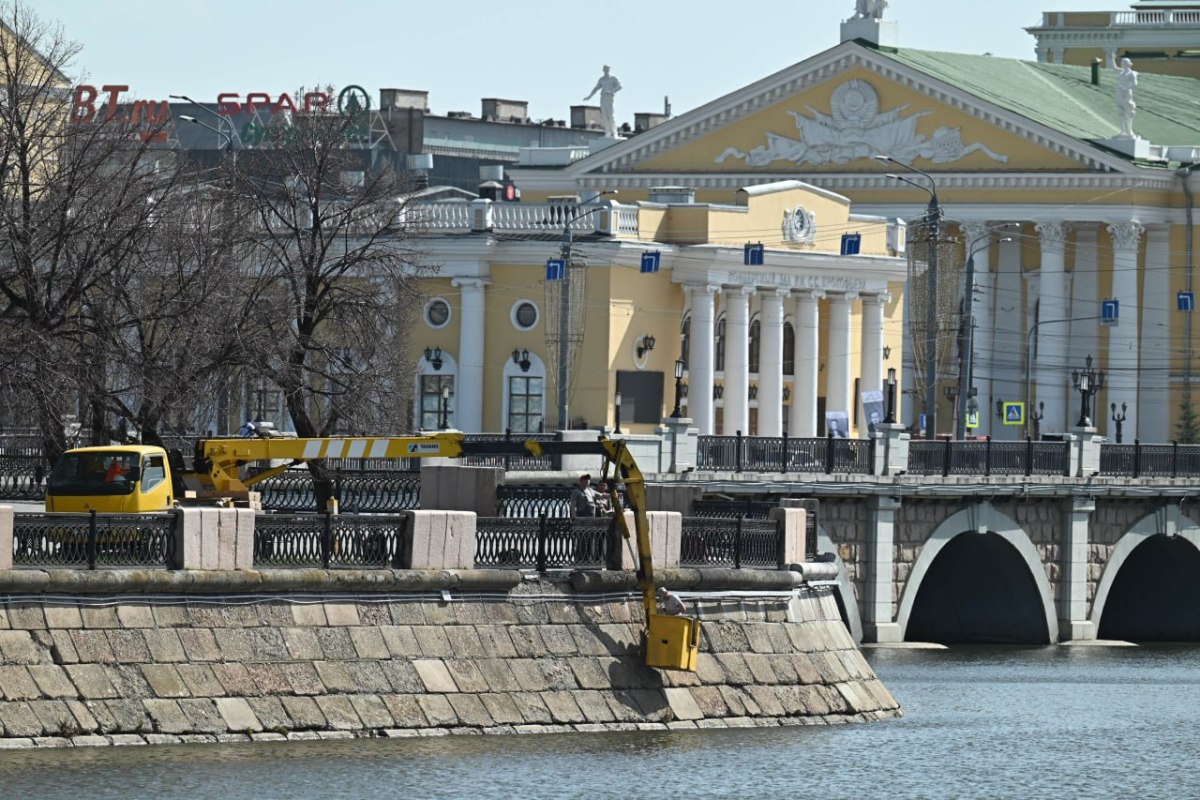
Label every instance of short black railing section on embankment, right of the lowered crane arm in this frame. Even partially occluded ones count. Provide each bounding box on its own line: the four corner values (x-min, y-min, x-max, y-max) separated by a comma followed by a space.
679, 517, 784, 569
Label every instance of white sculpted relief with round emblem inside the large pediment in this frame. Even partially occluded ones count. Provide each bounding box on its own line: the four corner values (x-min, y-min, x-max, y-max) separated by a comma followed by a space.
715, 78, 1008, 167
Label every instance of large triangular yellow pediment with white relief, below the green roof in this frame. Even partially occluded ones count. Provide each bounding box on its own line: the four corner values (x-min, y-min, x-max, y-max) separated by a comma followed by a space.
552, 42, 1152, 184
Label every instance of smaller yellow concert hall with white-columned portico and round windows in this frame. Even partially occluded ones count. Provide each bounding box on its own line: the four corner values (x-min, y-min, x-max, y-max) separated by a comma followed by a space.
414, 180, 906, 437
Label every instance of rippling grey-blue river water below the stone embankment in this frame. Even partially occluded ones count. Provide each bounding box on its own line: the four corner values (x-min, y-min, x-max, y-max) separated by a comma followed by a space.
0, 646, 1200, 800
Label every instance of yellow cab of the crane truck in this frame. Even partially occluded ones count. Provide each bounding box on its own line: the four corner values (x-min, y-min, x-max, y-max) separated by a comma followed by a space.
46, 445, 175, 513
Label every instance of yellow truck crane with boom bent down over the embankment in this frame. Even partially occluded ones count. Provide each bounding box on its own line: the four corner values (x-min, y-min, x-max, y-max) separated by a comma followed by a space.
46, 432, 700, 672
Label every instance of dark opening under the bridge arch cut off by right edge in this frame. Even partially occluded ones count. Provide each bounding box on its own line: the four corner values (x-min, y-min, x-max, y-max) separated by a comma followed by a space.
1098, 536, 1200, 642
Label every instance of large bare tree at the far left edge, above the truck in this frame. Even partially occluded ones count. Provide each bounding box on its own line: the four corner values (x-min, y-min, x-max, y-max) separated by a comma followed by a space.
0, 0, 179, 458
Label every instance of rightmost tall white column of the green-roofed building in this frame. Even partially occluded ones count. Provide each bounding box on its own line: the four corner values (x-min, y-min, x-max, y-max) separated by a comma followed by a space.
1137, 225, 1178, 441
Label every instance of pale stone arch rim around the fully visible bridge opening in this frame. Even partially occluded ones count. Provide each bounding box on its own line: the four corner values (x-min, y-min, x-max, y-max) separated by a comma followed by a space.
896, 503, 1058, 642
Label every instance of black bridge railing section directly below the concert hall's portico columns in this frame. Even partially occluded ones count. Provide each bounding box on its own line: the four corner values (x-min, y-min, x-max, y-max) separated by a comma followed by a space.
696, 433, 875, 475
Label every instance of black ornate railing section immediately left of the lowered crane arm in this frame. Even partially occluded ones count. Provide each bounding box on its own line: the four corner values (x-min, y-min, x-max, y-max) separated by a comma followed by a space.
475, 516, 620, 572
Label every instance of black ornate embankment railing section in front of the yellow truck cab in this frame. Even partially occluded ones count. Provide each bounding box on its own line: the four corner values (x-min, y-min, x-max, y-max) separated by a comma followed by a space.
12, 512, 179, 570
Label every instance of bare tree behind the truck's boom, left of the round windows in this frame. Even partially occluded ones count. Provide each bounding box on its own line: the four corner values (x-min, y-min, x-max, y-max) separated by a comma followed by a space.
225, 105, 428, 500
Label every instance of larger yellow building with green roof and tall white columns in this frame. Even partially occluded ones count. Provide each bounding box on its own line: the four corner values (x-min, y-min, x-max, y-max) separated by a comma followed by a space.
511, 4, 1200, 441
